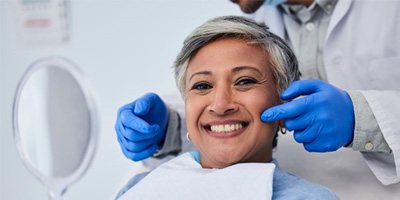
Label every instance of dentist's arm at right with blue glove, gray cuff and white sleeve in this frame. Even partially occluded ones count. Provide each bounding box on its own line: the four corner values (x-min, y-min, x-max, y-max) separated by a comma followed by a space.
261, 80, 400, 185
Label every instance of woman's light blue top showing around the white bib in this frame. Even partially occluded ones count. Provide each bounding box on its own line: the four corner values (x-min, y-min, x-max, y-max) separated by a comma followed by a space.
115, 152, 339, 200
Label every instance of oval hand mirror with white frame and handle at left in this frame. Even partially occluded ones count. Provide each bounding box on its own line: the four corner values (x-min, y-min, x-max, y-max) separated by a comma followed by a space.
13, 57, 97, 199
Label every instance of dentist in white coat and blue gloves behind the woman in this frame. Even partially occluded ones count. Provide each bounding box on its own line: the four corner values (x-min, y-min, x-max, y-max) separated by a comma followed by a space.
116, 0, 400, 185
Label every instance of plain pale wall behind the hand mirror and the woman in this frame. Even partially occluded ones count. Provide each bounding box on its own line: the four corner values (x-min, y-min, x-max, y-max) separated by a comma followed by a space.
0, 0, 240, 200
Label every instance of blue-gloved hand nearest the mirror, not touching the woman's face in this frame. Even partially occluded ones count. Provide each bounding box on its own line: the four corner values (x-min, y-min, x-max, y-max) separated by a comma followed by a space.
115, 93, 169, 161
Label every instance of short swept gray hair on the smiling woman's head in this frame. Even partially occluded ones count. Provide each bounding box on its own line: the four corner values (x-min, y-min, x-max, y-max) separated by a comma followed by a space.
174, 16, 300, 97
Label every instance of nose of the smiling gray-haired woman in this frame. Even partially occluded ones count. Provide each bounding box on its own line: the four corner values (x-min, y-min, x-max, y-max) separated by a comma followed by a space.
208, 90, 239, 115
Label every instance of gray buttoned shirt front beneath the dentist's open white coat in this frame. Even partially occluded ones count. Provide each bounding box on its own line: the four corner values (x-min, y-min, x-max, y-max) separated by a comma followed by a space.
280, 0, 337, 81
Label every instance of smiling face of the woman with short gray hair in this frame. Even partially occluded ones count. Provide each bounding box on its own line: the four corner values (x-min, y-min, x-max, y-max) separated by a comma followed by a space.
185, 38, 278, 168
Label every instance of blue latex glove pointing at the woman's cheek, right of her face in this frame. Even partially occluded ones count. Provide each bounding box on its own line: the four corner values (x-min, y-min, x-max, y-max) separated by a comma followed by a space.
261, 80, 354, 152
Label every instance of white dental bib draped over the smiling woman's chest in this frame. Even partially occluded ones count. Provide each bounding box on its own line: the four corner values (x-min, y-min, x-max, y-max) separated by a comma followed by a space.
120, 153, 275, 200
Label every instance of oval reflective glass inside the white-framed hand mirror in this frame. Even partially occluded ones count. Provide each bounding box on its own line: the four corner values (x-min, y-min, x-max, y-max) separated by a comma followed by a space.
18, 68, 90, 177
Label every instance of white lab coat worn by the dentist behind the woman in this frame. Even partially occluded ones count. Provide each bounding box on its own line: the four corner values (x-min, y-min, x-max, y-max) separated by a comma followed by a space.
253, 0, 400, 185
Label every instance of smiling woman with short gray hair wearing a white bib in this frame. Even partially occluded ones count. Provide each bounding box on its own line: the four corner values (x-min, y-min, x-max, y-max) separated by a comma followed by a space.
118, 16, 337, 199
